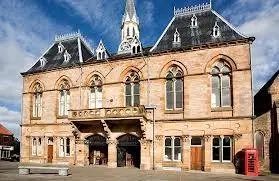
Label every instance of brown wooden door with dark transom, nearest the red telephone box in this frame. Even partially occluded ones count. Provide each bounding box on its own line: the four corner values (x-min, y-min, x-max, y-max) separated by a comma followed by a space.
191, 137, 203, 170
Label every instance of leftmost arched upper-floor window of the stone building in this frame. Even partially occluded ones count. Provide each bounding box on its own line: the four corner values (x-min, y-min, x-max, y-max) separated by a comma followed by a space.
32, 83, 43, 118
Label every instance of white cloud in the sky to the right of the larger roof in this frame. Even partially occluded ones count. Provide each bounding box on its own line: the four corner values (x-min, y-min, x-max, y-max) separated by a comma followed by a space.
223, 0, 279, 93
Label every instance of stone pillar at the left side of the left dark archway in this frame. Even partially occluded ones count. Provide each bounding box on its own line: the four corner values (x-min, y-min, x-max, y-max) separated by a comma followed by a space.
75, 139, 88, 166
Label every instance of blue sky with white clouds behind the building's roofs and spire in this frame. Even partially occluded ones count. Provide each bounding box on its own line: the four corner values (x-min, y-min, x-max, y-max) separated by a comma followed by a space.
0, 0, 279, 139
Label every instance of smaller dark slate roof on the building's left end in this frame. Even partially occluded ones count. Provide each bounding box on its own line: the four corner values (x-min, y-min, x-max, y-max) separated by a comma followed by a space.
23, 37, 93, 74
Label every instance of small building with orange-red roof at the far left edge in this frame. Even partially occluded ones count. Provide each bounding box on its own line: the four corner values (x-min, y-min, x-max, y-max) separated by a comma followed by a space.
0, 124, 14, 159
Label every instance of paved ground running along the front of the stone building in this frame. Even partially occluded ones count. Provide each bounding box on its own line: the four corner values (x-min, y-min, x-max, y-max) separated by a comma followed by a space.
0, 161, 279, 181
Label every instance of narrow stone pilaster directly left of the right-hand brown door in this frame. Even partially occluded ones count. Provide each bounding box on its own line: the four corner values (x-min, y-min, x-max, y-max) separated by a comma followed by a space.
182, 135, 191, 171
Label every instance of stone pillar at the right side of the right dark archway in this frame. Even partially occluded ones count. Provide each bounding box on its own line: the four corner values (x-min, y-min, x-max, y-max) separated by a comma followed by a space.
140, 139, 152, 170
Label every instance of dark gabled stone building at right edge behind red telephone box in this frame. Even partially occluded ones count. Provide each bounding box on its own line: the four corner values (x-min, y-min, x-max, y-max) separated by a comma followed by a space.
254, 70, 279, 172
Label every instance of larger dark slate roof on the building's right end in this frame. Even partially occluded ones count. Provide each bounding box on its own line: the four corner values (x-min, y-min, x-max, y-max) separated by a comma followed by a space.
151, 10, 246, 52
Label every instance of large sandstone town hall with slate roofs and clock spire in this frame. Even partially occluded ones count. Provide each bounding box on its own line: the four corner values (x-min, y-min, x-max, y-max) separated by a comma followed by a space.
21, 0, 254, 172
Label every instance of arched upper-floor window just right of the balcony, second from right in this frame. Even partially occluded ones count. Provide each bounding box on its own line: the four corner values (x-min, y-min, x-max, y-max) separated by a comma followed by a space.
166, 66, 183, 110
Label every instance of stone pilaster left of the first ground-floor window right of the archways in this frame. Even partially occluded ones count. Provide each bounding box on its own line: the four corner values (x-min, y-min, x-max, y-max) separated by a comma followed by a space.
154, 135, 164, 170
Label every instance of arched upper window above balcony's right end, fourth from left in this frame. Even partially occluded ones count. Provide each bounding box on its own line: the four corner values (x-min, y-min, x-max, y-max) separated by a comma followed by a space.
125, 71, 140, 106
